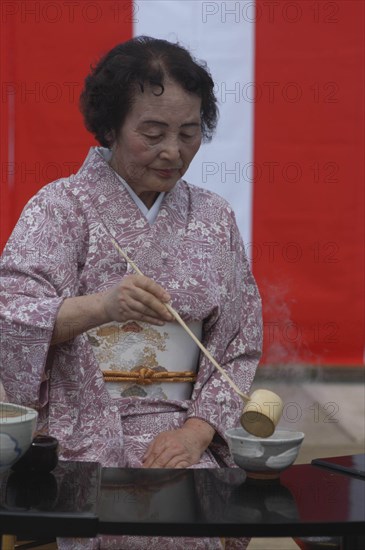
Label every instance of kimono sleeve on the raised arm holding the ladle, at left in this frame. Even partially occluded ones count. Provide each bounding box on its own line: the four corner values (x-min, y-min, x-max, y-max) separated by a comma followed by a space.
0, 180, 85, 408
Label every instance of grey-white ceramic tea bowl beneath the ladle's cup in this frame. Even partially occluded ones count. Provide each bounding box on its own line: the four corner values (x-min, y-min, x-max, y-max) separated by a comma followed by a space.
226, 428, 304, 479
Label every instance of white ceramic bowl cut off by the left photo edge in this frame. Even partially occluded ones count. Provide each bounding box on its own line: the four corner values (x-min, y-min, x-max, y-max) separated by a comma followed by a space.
0, 402, 38, 473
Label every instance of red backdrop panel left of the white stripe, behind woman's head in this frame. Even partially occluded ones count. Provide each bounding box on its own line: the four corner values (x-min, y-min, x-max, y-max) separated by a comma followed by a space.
0, 0, 133, 247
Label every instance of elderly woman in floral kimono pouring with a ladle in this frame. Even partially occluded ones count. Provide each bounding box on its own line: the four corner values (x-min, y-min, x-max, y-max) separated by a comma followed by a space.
1, 37, 261, 550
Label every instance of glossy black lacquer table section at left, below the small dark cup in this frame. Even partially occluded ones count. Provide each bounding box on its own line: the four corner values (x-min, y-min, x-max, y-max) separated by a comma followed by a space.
0, 462, 100, 539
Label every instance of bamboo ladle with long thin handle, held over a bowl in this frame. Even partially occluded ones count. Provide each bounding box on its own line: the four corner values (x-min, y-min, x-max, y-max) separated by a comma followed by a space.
112, 239, 283, 437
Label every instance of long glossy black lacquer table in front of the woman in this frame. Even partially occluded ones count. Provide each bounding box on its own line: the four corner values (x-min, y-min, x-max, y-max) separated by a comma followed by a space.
0, 462, 365, 550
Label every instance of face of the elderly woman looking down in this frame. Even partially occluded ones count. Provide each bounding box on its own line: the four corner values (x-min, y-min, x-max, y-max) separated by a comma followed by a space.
110, 80, 201, 208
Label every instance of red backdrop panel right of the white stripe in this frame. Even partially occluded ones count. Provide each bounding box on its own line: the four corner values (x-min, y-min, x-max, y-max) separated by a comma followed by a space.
252, 0, 365, 365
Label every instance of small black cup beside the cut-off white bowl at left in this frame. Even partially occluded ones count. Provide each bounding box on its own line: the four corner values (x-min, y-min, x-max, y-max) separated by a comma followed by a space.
11, 435, 58, 473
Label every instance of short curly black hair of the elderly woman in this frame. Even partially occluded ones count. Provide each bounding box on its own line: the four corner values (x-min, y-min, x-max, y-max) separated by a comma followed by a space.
80, 36, 218, 147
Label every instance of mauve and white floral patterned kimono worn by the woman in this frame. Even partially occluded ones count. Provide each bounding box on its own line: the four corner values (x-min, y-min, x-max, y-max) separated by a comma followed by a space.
0, 148, 262, 550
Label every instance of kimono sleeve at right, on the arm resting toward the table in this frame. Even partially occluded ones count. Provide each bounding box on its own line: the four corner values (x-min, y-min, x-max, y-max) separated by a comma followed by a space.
188, 207, 262, 440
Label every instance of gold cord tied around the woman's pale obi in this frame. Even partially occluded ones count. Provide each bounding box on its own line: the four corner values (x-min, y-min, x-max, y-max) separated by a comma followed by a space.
103, 367, 196, 384
